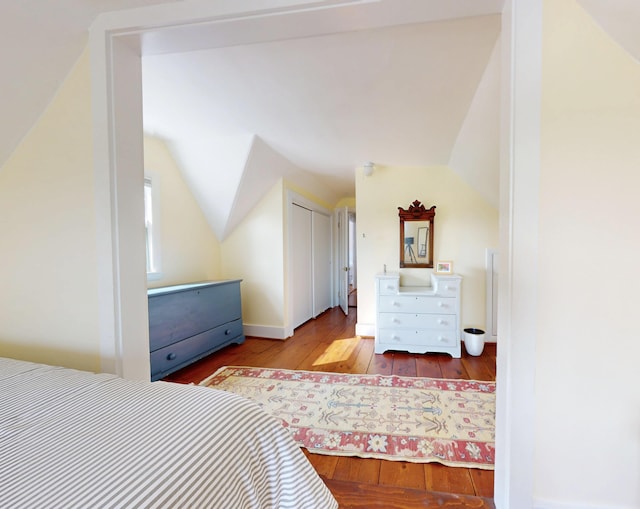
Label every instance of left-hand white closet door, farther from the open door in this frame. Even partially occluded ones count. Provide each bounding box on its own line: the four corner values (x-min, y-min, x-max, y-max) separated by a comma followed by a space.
291, 203, 313, 328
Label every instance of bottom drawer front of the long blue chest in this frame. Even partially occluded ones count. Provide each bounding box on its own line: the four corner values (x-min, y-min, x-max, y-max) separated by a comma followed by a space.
151, 319, 244, 380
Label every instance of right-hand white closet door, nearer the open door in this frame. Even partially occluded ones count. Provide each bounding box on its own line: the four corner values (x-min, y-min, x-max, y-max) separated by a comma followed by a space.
311, 211, 331, 317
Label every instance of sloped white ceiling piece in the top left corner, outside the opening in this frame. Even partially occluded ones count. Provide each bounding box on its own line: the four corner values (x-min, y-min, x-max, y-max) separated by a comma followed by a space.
0, 0, 175, 167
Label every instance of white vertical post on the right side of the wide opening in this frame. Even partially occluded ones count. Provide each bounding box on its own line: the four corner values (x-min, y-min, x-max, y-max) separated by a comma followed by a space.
494, 0, 543, 509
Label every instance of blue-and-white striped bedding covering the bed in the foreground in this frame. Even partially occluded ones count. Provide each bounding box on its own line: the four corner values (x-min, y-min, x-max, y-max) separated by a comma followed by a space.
0, 358, 337, 509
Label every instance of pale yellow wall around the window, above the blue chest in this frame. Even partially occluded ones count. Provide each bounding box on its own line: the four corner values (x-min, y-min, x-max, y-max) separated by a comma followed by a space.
144, 136, 221, 288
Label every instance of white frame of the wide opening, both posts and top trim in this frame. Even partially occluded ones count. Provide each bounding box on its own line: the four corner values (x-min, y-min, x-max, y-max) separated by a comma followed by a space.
90, 0, 542, 509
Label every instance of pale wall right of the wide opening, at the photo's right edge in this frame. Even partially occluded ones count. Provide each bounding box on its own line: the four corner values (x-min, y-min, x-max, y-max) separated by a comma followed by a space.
535, 0, 640, 509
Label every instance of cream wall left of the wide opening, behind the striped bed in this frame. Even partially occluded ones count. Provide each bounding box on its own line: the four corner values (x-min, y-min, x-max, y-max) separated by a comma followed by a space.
0, 52, 100, 370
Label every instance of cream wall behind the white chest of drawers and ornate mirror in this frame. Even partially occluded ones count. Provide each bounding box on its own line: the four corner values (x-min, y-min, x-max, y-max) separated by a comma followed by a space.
356, 166, 498, 334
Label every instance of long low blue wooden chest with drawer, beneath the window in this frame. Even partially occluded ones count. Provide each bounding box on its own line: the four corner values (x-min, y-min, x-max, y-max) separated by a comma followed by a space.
147, 279, 244, 380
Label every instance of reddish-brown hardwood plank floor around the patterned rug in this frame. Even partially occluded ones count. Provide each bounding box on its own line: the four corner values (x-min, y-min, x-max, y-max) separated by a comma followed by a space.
165, 308, 496, 509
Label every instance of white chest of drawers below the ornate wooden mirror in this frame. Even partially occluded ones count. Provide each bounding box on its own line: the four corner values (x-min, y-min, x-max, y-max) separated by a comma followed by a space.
375, 273, 462, 358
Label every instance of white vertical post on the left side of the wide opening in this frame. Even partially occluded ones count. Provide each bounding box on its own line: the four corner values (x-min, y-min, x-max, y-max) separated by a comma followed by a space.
91, 31, 151, 380
